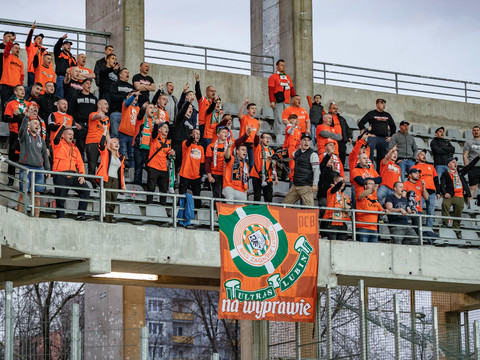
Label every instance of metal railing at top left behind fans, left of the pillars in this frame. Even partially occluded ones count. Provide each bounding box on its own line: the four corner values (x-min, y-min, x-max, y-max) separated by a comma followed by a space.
0, 18, 111, 54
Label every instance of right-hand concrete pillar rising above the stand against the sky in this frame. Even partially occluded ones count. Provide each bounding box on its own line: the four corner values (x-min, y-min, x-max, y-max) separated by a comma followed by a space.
250, 0, 313, 100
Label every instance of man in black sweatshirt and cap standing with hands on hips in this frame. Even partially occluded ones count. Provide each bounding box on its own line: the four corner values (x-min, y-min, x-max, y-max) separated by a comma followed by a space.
358, 99, 397, 169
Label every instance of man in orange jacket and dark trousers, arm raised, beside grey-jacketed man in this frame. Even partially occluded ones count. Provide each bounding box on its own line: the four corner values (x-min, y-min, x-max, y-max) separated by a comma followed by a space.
52, 118, 90, 220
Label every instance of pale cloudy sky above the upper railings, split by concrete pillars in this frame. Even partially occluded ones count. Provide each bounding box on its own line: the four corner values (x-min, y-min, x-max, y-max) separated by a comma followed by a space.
2, 0, 480, 82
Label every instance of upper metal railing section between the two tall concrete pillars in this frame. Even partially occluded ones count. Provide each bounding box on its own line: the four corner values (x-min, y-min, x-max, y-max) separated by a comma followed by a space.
145, 39, 275, 75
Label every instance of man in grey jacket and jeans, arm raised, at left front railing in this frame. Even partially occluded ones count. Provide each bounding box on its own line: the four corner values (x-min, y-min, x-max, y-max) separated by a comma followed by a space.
17, 103, 50, 217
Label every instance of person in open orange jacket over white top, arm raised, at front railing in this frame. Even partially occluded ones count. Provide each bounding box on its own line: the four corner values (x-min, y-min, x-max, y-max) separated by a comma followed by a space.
95, 125, 125, 223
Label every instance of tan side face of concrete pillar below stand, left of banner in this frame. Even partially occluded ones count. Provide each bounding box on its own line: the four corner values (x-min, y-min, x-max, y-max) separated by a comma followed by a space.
123, 286, 145, 360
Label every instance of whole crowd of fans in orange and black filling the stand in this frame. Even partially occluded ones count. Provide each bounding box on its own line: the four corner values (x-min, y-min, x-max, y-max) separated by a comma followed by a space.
0, 23, 480, 240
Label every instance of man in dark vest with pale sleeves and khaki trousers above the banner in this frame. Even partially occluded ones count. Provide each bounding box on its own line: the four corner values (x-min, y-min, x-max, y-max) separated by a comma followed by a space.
283, 133, 320, 206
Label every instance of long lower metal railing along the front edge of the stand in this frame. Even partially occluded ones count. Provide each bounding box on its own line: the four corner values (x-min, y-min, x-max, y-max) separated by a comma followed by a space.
0, 156, 480, 247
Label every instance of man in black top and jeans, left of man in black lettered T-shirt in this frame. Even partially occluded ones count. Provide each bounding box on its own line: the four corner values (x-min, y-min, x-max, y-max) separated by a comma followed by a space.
110, 68, 134, 138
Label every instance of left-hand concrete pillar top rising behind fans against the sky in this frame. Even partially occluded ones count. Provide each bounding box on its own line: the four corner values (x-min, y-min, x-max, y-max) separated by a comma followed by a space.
85, 0, 145, 72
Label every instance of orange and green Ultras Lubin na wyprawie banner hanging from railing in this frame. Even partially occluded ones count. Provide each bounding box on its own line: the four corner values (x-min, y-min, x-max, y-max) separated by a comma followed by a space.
217, 203, 318, 322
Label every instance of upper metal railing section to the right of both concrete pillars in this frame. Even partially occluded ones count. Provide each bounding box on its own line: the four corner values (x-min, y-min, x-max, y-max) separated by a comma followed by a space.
313, 61, 480, 103
